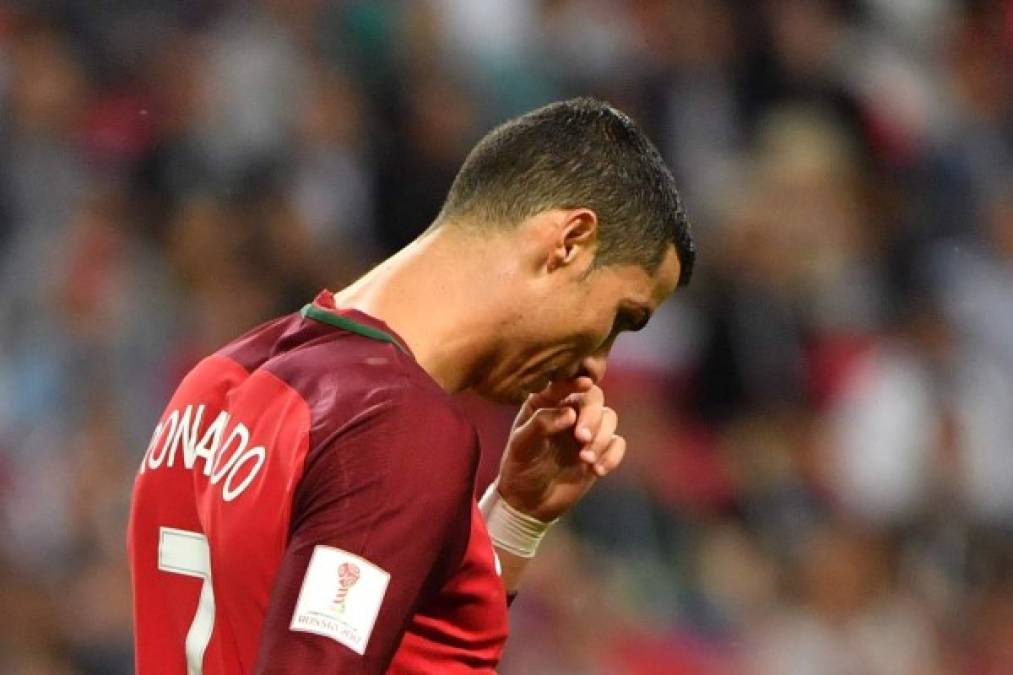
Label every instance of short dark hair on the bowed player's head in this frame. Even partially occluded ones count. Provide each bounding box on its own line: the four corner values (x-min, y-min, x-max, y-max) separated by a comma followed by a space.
435, 97, 696, 286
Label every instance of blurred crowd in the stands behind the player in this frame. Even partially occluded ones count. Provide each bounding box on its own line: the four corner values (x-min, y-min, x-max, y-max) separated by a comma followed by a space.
0, 0, 1013, 675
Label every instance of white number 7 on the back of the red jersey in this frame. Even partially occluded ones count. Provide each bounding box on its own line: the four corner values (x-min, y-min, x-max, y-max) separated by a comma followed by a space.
158, 527, 215, 675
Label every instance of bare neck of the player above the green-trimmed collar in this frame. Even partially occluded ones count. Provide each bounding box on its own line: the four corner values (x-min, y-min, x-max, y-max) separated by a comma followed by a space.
335, 225, 510, 392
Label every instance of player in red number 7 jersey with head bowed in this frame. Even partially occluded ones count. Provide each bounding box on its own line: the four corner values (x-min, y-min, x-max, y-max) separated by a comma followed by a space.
129, 98, 694, 675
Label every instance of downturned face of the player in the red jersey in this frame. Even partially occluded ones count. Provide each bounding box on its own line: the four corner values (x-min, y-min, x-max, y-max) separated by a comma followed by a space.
473, 246, 680, 402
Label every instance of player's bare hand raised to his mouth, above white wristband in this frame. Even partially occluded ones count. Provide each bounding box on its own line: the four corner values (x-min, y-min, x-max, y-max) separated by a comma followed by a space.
498, 377, 626, 522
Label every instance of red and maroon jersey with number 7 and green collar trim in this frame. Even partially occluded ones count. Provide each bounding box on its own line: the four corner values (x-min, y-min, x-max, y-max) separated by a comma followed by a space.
128, 292, 507, 675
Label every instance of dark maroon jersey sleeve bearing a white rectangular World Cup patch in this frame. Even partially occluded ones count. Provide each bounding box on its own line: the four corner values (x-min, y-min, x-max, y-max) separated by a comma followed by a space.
256, 387, 477, 674
